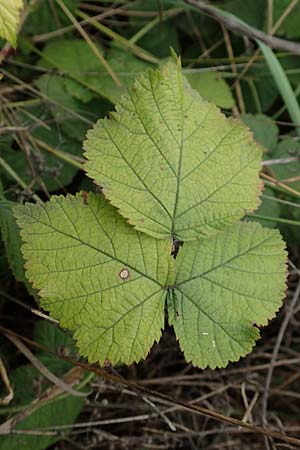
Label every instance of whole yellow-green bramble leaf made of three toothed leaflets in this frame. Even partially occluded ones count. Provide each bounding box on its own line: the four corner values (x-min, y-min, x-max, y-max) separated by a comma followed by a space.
15, 59, 286, 368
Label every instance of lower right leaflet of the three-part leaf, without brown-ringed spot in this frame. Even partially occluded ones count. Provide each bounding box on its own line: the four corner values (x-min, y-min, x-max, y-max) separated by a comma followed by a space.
168, 223, 286, 368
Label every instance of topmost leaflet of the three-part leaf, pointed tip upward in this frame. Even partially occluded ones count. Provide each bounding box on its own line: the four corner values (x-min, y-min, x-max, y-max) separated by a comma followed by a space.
85, 62, 261, 241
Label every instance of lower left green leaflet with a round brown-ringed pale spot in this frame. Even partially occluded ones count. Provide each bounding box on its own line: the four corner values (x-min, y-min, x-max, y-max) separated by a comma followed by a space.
16, 194, 170, 364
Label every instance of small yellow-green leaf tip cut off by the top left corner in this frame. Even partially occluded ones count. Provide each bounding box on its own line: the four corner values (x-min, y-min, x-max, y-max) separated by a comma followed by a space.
0, 0, 23, 47
